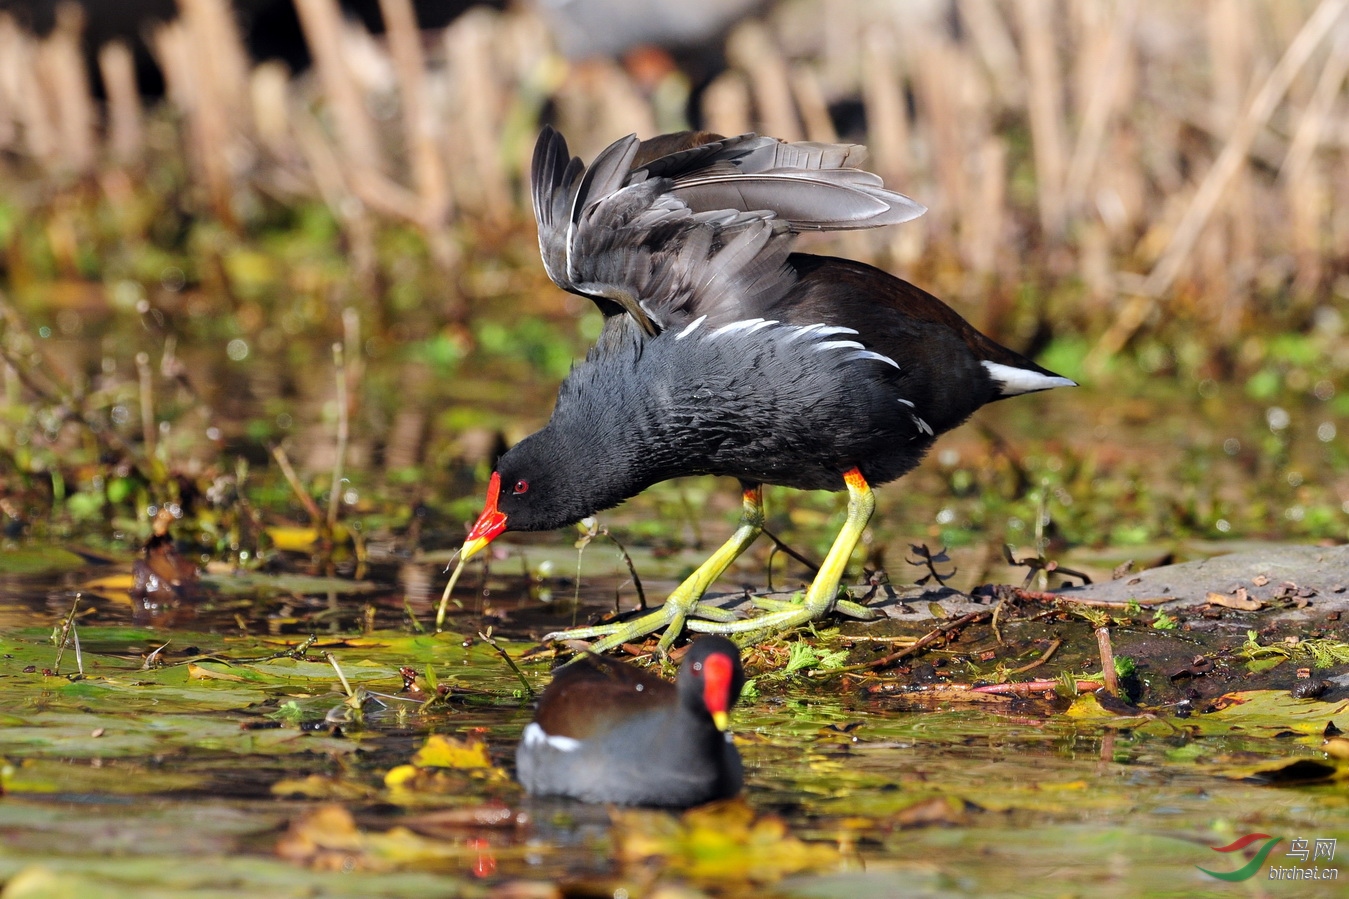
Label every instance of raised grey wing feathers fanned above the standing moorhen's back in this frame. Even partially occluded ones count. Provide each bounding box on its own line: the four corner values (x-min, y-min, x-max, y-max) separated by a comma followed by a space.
533, 128, 924, 333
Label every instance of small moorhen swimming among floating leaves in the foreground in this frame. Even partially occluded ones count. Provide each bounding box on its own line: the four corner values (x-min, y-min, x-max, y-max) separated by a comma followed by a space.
515, 637, 745, 807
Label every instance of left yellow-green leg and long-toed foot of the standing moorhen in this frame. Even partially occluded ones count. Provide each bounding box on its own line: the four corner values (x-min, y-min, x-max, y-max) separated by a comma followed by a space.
544, 483, 764, 652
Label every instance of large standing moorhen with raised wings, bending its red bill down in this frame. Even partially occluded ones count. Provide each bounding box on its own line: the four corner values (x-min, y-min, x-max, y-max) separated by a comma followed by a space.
441, 128, 1074, 652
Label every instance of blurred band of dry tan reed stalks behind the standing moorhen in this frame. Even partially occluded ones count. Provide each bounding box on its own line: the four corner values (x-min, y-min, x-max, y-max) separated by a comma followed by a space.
0, 0, 1349, 362
